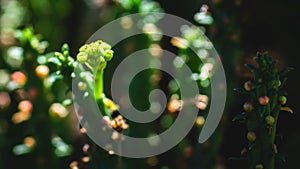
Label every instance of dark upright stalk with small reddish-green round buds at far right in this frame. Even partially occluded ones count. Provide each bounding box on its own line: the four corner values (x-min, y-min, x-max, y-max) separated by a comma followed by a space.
233, 53, 293, 169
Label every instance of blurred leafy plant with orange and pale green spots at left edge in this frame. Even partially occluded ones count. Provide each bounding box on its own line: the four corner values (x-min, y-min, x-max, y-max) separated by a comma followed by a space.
0, 28, 74, 160
